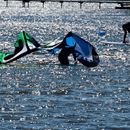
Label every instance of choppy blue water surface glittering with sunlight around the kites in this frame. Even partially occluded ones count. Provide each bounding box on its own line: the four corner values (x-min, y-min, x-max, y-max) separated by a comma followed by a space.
0, 2, 130, 130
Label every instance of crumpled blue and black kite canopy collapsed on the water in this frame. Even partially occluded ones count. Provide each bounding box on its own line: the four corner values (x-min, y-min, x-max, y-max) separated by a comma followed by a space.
46, 32, 100, 67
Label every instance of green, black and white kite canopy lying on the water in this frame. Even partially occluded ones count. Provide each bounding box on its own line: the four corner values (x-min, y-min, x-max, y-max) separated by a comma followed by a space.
0, 31, 40, 64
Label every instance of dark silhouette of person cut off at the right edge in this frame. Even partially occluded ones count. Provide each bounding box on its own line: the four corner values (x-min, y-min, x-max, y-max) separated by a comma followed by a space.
122, 22, 130, 43
